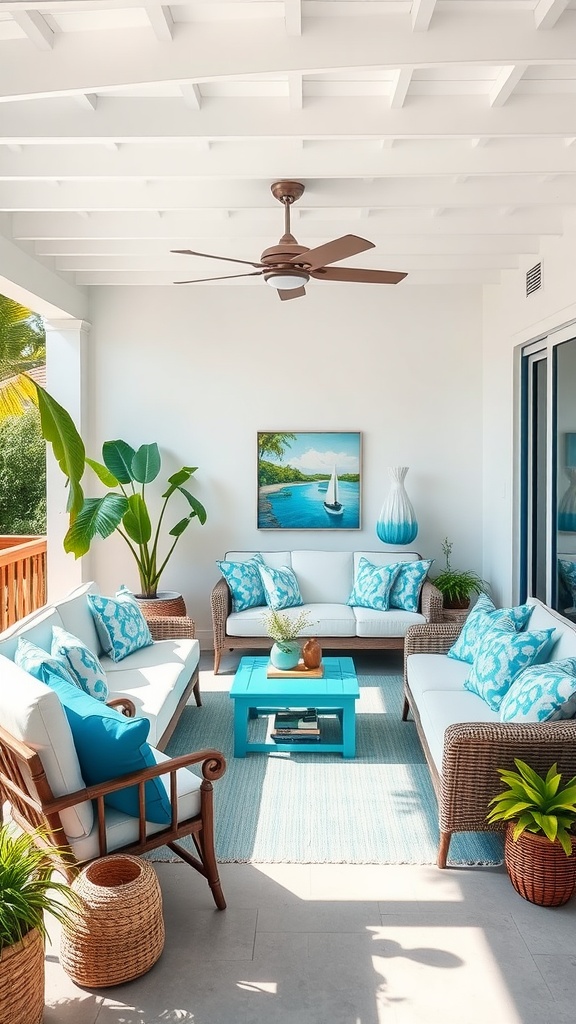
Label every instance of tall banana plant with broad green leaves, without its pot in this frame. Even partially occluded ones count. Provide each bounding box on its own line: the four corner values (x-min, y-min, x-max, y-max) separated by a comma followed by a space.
30, 383, 206, 597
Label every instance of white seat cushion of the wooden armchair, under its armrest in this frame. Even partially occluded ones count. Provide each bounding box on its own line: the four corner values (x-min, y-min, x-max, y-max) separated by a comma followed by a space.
70, 748, 202, 863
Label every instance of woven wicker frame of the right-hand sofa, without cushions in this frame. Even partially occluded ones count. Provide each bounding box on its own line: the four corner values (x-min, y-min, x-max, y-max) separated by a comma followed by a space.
402, 612, 576, 867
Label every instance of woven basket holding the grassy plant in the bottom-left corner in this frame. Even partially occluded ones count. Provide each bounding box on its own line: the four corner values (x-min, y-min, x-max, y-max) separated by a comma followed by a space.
0, 928, 44, 1024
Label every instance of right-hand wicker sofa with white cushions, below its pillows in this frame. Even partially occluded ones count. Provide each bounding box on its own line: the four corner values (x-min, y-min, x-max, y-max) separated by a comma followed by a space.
402, 598, 576, 867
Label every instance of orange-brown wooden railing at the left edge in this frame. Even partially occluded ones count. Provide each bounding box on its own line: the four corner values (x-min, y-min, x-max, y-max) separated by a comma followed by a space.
0, 536, 46, 632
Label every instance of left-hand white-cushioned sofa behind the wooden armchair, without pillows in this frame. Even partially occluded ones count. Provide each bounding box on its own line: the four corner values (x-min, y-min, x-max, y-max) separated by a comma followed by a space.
0, 583, 200, 750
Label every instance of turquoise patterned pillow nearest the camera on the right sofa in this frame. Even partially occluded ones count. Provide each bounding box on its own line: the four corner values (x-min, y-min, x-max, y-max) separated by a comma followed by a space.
500, 657, 576, 722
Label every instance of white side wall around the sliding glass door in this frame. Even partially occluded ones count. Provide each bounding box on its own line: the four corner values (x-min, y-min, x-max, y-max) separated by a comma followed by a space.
482, 210, 576, 603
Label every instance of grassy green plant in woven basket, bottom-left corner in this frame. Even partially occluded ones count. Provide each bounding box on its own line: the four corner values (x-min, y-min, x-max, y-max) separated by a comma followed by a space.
0, 824, 78, 1024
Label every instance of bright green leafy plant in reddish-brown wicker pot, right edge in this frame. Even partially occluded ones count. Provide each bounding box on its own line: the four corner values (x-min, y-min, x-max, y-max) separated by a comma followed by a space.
487, 758, 576, 906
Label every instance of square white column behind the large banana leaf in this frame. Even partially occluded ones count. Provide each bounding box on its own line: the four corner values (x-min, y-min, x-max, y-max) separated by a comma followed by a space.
45, 319, 90, 601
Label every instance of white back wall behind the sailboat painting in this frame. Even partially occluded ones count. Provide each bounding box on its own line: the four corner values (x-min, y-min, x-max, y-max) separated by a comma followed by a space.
84, 283, 483, 646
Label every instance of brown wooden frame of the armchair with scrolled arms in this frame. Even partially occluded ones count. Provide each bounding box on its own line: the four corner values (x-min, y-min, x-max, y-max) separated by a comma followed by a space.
0, 727, 225, 910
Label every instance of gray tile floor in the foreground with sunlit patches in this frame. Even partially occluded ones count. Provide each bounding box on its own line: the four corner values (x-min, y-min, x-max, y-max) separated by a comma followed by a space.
42, 656, 576, 1024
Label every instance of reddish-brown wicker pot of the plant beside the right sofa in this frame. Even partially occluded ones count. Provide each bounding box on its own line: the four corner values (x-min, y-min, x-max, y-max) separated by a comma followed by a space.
504, 822, 576, 906
